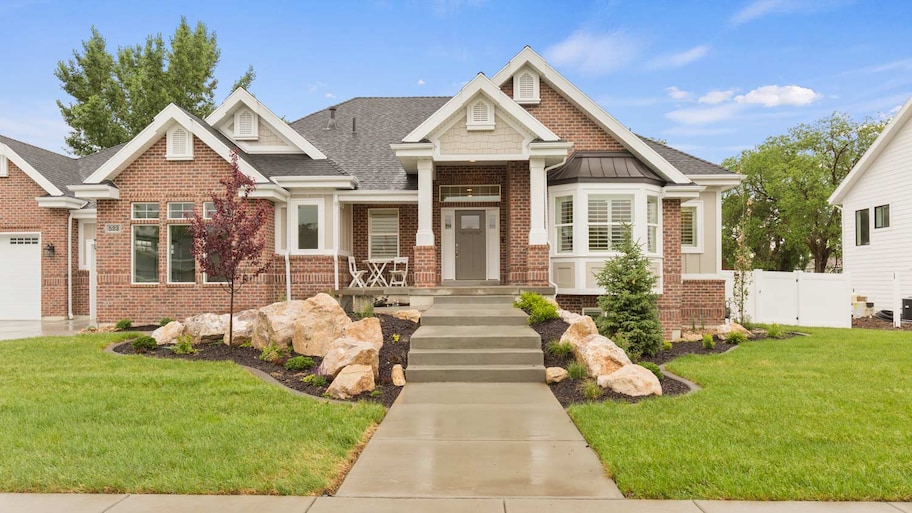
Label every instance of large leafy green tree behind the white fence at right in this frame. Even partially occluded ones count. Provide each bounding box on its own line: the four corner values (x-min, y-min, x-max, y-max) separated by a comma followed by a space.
722, 113, 886, 272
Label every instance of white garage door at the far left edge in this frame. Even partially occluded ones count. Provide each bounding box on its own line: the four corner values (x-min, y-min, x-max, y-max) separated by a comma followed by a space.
0, 233, 41, 320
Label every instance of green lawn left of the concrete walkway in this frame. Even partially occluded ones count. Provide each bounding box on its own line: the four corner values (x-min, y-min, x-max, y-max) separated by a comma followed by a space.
0, 333, 384, 495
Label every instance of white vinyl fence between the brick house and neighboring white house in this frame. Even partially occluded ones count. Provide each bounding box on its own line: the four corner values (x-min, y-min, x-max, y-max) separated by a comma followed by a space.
722, 269, 852, 328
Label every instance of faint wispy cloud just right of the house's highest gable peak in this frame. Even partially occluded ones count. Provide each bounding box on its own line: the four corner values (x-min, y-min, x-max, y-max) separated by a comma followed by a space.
545, 30, 641, 75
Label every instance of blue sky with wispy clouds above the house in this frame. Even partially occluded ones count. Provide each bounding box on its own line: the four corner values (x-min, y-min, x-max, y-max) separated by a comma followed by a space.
0, 0, 912, 162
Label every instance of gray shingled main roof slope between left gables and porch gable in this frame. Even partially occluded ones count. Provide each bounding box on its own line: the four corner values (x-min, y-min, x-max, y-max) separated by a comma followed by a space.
291, 96, 450, 190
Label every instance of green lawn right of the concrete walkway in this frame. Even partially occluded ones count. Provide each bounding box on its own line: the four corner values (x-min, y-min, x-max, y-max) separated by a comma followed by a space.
569, 328, 912, 501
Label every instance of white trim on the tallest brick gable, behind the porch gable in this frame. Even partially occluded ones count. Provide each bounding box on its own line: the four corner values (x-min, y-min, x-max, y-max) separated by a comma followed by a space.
491, 46, 690, 184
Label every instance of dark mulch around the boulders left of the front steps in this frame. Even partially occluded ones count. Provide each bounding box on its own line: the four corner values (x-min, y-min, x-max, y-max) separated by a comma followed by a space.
115, 314, 418, 408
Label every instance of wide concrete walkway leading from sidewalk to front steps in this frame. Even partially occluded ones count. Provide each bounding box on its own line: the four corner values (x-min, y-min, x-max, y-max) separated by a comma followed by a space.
336, 383, 623, 499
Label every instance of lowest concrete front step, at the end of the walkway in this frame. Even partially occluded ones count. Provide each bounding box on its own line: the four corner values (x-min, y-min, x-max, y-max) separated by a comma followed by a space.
405, 362, 545, 383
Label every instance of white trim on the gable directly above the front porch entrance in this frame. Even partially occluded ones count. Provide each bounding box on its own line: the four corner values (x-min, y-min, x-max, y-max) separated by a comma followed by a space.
402, 73, 560, 143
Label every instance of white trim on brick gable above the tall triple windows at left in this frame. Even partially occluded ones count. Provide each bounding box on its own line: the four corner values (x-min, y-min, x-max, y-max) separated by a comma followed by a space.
83, 103, 269, 184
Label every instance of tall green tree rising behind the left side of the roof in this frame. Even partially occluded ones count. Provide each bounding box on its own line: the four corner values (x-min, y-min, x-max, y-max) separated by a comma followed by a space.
54, 18, 255, 155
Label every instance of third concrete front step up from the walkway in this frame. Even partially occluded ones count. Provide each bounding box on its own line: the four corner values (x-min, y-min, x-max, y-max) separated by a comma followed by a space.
411, 326, 541, 350
